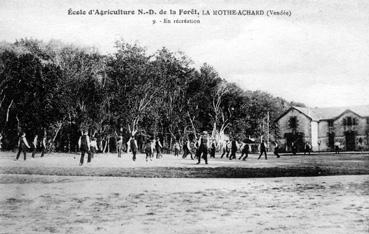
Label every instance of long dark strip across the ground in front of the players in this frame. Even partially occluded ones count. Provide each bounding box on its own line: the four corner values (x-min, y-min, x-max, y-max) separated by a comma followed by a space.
0, 166, 369, 178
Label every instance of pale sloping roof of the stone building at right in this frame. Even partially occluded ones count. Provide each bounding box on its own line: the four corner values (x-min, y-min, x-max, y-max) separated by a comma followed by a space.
291, 105, 369, 121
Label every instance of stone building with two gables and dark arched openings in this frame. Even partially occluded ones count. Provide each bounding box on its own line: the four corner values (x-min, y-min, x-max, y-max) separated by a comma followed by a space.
275, 105, 369, 151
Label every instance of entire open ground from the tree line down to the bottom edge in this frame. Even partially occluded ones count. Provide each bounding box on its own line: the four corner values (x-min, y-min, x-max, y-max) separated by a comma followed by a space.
0, 152, 369, 234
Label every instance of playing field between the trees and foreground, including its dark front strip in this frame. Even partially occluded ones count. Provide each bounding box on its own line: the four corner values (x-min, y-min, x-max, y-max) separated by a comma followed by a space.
0, 152, 369, 178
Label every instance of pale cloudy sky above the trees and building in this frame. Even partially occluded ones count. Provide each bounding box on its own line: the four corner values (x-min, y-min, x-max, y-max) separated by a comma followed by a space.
0, 0, 369, 107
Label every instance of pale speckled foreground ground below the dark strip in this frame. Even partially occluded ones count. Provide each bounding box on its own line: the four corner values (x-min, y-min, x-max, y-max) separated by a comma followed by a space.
0, 175, 369, 233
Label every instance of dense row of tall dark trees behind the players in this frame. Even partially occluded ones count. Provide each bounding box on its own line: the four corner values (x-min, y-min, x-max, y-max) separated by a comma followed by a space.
0, 39, 300, 151
